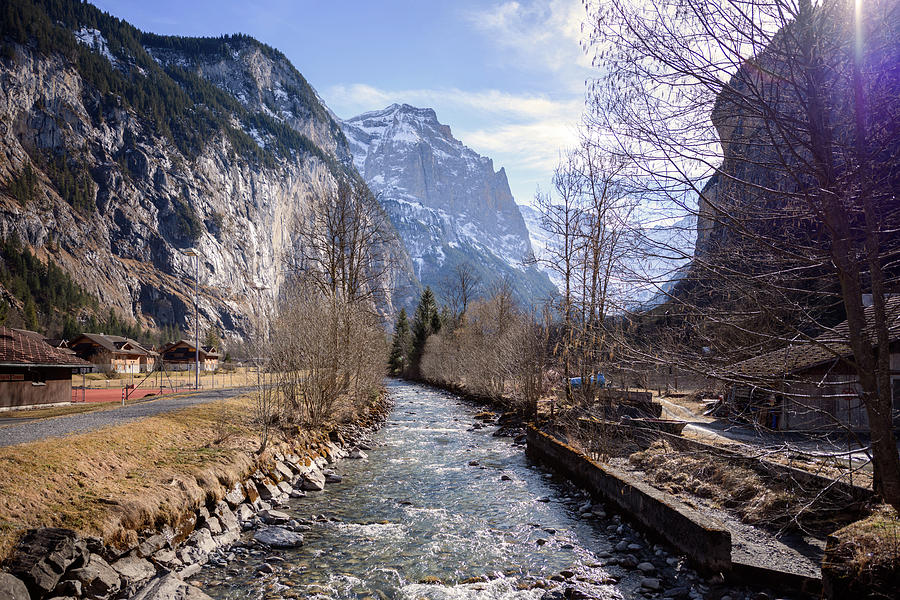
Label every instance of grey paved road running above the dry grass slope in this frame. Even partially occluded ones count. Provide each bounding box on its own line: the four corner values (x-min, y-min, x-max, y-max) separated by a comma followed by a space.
0, 387, 252, 446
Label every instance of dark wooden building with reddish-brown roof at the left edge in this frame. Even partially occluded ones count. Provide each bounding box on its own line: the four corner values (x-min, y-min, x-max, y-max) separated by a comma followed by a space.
0, 327, 91, 411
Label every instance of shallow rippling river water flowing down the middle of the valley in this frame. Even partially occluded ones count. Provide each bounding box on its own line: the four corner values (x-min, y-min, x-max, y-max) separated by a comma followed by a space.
194, 381, 724, 600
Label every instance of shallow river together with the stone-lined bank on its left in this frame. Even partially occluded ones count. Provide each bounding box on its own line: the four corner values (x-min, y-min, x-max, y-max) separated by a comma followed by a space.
0, 382, 796, 600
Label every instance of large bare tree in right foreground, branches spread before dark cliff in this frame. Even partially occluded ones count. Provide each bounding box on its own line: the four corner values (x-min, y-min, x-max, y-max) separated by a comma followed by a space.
590, 0, 900, 508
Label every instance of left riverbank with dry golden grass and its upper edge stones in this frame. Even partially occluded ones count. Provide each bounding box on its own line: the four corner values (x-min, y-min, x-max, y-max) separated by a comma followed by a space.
0, 386, 389, 600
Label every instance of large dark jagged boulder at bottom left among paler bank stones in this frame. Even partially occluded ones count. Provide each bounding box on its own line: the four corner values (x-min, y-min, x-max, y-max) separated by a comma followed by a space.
6, 527, 88, 596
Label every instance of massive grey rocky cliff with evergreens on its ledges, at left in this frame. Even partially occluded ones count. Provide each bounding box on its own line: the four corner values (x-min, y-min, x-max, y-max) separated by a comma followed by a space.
0, 2, 411, 334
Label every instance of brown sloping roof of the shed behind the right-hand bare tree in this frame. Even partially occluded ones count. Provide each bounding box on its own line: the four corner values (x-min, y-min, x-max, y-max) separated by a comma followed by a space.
731, 295, 900, 377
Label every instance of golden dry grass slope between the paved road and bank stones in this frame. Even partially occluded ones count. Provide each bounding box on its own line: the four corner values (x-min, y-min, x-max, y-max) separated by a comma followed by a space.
0, 397, 257, 559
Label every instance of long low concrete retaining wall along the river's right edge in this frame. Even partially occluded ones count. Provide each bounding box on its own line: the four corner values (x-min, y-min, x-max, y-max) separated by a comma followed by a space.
527, 426, 731, 571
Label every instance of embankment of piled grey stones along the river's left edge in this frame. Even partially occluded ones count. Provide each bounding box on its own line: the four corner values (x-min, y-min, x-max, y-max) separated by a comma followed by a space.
0, 403, 388, 600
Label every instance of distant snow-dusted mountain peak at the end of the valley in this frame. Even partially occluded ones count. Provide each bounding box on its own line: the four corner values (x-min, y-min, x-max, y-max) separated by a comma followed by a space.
342, 104, 555, 302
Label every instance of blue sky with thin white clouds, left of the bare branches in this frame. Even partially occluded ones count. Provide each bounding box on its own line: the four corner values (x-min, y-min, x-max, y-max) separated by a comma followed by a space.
93, 0, 594, 204
